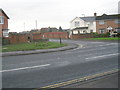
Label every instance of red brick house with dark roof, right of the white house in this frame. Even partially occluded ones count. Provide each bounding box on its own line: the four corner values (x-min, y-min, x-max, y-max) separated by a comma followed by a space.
96, 14, 120, 35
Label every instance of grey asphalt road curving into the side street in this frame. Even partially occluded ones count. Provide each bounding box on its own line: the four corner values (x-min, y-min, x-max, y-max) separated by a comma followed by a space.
1, 40, 118, 88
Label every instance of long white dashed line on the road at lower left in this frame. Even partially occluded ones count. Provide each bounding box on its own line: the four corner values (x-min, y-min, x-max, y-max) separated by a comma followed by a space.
0, 64, 50, 72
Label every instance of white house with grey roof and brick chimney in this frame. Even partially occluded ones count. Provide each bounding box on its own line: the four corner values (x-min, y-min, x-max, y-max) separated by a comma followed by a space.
70, 13, 96, 35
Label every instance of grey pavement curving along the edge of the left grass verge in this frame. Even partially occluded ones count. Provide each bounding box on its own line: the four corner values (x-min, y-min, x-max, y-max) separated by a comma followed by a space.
0, 44, 78, 57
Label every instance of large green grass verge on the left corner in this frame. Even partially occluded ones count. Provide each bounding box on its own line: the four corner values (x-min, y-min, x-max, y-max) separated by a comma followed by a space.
2, 42, 67, 52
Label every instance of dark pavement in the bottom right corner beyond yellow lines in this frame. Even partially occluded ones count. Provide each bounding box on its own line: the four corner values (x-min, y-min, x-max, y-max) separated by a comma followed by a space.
62, 73, 120, 88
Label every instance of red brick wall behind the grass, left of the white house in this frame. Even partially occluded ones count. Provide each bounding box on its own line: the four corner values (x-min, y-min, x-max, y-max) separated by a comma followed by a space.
43, 32, 68, 39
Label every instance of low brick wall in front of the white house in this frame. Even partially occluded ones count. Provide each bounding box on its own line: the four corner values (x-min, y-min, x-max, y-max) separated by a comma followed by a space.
70, 34, 93, 39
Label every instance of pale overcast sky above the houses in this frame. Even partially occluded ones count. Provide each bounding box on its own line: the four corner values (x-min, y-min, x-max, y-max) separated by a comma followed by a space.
0, 0, 119, 32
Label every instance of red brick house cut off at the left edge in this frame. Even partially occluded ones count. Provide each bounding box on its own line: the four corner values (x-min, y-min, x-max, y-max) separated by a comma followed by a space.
0, 9, 9, 37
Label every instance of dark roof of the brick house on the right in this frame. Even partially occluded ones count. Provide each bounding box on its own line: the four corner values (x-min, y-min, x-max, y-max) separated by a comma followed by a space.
96, 14, 120, 20
